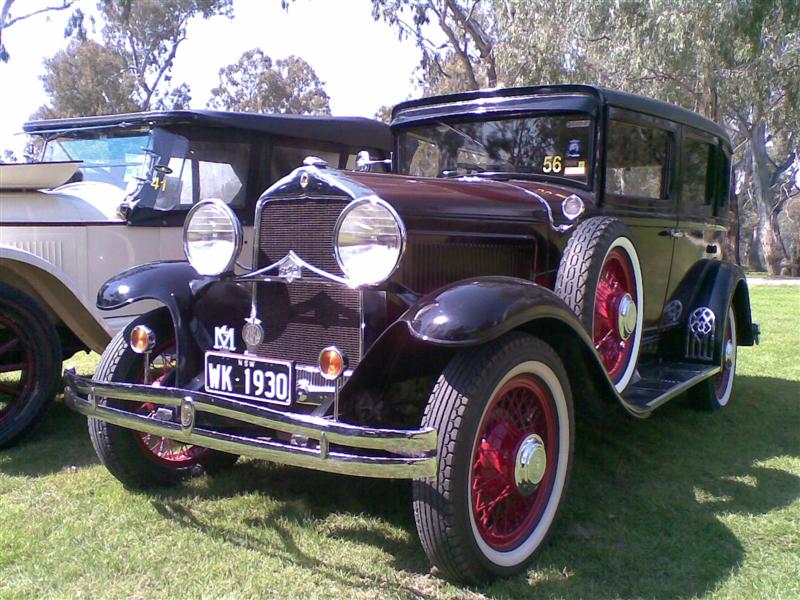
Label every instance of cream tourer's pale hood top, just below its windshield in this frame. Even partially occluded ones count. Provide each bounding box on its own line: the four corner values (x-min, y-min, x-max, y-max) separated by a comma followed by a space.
0, 181, 125, 225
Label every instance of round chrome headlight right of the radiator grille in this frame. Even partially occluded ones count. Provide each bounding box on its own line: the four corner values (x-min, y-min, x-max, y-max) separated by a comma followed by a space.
334, 198, 405, 285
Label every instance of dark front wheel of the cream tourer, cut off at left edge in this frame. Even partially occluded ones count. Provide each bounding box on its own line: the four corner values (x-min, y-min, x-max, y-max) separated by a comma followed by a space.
0, 284, 62, 448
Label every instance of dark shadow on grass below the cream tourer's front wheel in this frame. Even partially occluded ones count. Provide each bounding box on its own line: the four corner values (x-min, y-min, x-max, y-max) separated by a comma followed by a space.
0, 401, 99, 477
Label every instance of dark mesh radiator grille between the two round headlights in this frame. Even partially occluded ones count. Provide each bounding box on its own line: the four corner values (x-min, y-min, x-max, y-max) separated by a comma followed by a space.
256, 199, 361, 367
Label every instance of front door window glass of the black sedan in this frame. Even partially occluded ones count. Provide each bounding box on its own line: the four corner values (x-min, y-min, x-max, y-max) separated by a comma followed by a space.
606, 120, 670, 199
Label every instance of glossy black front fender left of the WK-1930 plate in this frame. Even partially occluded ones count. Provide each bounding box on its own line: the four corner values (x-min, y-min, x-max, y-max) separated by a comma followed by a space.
97, 261, 205, 386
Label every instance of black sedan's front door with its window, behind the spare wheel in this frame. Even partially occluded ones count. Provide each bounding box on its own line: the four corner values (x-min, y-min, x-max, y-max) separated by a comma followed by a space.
603, 108, 678, 330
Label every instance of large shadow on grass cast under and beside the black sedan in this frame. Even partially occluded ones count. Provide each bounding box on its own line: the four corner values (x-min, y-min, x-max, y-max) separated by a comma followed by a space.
151, 377, 800, 598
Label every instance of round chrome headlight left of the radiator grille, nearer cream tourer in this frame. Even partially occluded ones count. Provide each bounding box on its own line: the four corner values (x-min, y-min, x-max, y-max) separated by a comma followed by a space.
183, 200, 242, 275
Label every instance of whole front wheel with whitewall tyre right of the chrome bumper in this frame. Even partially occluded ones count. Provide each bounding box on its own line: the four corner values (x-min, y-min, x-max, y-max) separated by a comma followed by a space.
414, 334, 573, 582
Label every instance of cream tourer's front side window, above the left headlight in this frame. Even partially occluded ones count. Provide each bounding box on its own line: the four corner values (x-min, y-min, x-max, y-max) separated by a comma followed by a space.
151, 140, 250, 210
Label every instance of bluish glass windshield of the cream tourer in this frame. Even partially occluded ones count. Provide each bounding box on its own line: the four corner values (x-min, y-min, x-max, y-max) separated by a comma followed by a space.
42, 130, 152, 192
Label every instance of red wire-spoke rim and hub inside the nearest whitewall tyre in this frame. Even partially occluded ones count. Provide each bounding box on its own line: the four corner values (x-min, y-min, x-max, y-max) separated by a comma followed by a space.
470, 375, 558, 550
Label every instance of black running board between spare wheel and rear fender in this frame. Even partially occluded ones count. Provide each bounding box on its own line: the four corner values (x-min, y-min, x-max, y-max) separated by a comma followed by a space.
622, 363, 720, 412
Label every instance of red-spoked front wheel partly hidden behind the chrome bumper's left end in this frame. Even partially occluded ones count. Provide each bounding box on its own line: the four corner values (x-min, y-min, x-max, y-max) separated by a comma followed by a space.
89, 313, 237, 488
